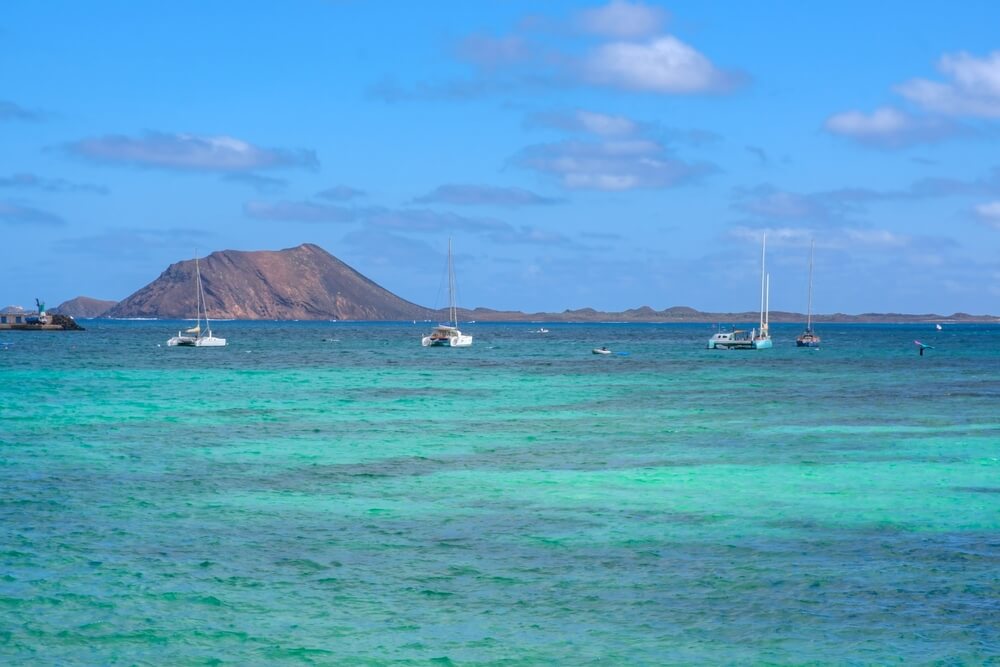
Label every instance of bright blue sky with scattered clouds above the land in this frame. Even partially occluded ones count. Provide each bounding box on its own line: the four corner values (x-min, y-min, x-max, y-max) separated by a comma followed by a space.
0, 0, 1000, 314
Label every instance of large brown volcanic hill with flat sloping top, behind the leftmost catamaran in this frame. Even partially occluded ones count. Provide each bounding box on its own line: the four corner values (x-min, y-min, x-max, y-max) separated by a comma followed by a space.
106, 243, 431, 320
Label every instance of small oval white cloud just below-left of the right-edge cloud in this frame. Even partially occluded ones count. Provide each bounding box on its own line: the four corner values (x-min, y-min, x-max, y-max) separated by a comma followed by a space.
823, 107, 961, 149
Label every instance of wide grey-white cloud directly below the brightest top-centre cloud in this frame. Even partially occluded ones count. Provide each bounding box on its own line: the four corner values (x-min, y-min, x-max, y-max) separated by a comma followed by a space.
512, 139, 716, 191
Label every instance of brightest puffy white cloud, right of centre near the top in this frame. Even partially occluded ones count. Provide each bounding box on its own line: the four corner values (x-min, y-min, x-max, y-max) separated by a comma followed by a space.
582, 35, 736, 94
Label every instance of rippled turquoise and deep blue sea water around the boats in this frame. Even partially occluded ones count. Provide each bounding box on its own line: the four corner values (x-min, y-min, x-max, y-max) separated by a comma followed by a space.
0, 321, 1000, 665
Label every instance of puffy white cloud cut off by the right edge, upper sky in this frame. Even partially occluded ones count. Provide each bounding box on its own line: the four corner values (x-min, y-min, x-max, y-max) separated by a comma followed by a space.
896, 51, 1000, 118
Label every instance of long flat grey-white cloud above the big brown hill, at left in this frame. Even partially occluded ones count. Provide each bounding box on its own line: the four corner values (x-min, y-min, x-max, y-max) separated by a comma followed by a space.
65, 132, 319, 172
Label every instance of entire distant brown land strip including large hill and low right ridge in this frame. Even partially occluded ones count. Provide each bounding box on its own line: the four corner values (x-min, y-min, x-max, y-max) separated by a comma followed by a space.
53, 243, 1000, 323
